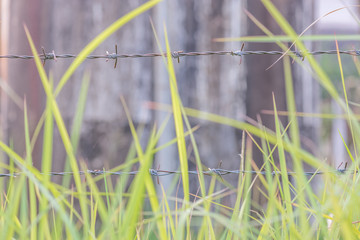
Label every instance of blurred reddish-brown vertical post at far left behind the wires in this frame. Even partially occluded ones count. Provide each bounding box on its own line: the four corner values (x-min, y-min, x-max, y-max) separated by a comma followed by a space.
6, 0, 44, 166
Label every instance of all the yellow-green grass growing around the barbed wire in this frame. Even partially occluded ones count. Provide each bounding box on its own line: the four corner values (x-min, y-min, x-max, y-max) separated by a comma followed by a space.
0, 0, 360, 240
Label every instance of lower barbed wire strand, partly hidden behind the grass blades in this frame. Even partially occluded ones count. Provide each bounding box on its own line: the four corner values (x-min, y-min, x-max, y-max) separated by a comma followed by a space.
0, 168, 358, 177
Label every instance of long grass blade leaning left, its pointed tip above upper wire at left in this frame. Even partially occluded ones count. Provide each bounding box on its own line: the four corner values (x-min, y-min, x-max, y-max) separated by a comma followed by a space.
25, 26, 89, 236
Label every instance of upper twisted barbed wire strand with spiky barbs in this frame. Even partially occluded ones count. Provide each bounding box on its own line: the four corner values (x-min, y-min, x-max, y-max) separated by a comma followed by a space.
0, 45, 360, 67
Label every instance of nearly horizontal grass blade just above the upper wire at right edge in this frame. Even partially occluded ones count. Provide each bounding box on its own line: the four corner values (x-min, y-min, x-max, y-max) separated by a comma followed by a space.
214, 34, 360, 43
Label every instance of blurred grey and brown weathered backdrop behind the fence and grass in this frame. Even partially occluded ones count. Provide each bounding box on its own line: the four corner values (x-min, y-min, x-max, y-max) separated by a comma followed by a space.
0, 0, 360, 204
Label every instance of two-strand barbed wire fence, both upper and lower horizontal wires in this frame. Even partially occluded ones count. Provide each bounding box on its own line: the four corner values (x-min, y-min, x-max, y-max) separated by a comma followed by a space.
0, 45, 360, 178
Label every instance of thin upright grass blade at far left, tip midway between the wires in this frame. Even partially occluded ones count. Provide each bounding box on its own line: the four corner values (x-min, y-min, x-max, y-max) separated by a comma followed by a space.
24, 100, 37, 240
